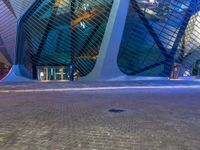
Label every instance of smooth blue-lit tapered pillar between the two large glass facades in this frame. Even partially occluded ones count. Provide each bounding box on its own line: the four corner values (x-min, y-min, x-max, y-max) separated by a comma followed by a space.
80, 0, 130, 81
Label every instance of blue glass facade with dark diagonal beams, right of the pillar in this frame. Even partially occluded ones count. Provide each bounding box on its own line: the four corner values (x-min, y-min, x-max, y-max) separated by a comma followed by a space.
118, 0, 200, 77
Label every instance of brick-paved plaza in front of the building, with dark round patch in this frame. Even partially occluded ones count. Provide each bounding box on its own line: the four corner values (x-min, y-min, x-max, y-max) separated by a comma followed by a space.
0, 82, 200, 150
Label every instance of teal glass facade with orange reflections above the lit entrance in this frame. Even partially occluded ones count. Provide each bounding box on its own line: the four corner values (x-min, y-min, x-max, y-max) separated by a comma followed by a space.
17, 0, 113, 79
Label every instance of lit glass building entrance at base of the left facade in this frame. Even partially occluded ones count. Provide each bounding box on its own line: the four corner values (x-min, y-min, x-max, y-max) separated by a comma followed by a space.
37, 66, 70, 81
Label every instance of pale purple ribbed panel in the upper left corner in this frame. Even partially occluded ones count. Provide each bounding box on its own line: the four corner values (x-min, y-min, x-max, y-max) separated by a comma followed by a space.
0, 0, 34, 63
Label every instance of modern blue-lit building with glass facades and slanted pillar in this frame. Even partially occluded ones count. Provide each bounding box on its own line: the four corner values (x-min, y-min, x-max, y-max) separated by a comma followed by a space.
0, 0, 200, 80
